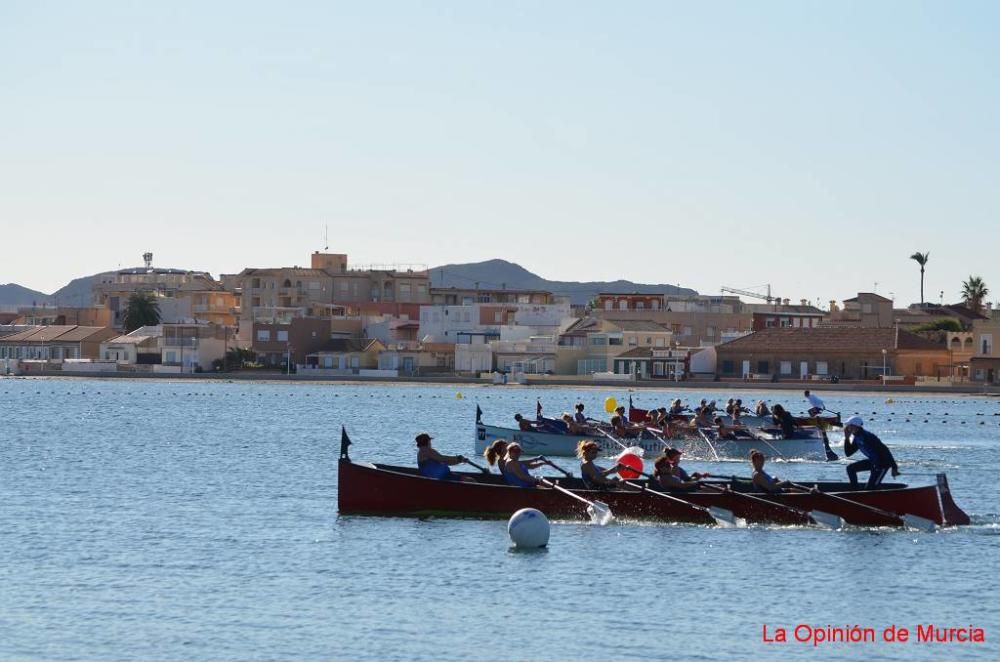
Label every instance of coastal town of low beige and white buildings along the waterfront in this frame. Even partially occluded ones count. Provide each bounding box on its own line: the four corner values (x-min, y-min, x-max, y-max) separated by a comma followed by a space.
0, 251, 1000, 385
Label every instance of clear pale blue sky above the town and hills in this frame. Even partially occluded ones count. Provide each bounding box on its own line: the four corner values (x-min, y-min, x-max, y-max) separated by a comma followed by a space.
0, 0, 1000, 306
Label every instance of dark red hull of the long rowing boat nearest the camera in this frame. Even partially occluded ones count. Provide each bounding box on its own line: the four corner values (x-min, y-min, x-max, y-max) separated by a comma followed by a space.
337, 453, 969, 526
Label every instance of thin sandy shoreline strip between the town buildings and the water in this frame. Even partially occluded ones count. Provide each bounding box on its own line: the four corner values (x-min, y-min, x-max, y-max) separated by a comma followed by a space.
9, 370, 1000, 397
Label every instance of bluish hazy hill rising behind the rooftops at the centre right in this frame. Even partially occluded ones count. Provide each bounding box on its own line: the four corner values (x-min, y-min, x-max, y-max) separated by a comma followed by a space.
430, 259, 697, 305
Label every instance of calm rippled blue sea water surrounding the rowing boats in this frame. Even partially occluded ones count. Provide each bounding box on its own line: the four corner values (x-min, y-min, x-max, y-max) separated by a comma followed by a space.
0, 379, 1000, 660
